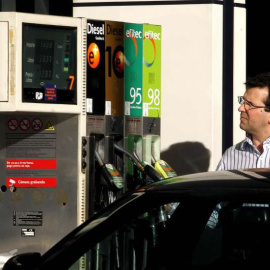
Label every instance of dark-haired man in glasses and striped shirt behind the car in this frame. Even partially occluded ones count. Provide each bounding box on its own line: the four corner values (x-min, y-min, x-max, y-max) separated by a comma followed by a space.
217, 73, 270, 170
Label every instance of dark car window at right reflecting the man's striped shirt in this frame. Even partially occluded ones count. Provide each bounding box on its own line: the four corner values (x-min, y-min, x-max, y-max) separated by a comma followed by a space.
192, 201, 270, 269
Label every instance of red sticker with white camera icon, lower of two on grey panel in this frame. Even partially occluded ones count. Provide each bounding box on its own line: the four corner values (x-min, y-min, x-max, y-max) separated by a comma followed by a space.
6, 177, 56, 187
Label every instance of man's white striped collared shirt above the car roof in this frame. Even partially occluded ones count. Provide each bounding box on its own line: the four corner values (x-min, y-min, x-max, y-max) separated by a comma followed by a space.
216, 135, 270, 171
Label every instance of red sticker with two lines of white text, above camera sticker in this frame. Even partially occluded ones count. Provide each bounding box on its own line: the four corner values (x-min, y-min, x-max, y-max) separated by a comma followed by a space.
6, 159, 56, 170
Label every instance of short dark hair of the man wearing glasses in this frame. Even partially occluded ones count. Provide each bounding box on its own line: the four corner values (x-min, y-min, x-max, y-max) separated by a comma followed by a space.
245, 72, 270, 107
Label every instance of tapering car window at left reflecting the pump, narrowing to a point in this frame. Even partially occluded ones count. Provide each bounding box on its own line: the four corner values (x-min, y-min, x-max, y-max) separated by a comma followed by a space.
69, 202, 180, 270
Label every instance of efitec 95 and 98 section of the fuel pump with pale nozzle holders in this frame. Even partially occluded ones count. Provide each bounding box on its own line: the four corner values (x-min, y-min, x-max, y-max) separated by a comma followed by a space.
124, 23, 166, 189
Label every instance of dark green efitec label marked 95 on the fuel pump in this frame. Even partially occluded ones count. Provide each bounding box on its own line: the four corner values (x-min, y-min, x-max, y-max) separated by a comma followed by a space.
124, 23, 143, 116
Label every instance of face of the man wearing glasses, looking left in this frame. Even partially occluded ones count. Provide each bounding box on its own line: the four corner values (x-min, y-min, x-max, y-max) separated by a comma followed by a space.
238, 87, 270, 135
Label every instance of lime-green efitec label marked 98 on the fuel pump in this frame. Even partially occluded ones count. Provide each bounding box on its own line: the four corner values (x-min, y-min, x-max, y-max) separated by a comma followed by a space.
143, 24, 161, 118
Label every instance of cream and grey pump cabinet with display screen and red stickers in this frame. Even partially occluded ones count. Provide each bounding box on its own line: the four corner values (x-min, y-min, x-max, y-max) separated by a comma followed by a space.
0, 12, 86, 254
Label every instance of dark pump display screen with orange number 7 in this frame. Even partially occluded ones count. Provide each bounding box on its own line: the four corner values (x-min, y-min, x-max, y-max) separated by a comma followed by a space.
22, 23, 77, 104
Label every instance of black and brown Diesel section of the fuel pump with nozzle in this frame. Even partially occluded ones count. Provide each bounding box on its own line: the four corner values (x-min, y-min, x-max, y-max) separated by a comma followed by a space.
84, 20, 124, 215
